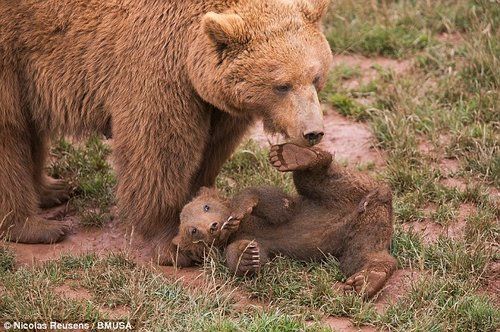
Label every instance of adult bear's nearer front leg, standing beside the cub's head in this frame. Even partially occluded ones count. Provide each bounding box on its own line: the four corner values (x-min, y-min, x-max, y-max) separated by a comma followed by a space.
113, 101, 209, 264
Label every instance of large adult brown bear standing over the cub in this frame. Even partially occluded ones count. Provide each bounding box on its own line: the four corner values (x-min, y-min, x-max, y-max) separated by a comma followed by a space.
0, 0, 331, 262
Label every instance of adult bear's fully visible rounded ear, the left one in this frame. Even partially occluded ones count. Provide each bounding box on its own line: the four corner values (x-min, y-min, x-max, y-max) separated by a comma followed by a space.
202, 12, 250, 50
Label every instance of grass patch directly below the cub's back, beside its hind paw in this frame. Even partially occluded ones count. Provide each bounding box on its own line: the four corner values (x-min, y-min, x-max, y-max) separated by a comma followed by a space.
205, 255, 376, 324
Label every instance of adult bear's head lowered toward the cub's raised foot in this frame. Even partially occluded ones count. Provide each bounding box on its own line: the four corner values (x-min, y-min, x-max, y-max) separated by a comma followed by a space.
188, 0, 332, 145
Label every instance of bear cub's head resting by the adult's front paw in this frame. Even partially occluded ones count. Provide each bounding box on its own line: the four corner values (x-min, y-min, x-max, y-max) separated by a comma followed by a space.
173, 187, 230, 251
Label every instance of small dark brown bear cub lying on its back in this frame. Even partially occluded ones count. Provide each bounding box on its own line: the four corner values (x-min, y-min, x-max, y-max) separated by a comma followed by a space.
172, 143, 396, 297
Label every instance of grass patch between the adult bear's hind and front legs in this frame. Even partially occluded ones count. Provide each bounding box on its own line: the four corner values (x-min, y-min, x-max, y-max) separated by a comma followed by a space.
49, 136, 116, 227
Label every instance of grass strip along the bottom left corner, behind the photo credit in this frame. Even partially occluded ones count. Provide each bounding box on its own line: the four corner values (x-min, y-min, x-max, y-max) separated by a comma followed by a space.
0, 254, 325, 331
